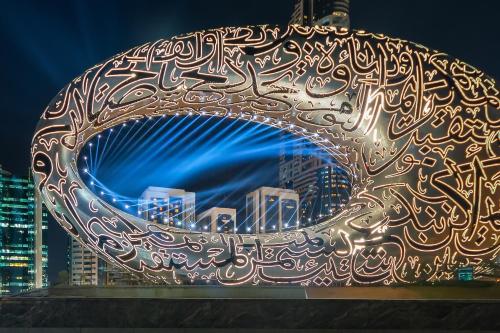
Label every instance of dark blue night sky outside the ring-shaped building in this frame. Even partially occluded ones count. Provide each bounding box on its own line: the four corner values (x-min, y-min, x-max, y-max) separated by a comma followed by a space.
0, 0, 500, 280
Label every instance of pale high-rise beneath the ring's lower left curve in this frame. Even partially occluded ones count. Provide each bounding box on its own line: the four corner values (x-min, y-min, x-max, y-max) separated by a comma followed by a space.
69, 238, 99, 286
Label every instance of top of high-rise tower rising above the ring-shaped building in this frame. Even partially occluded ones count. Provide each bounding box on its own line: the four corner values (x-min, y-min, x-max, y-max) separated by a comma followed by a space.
290, 0, 350, 28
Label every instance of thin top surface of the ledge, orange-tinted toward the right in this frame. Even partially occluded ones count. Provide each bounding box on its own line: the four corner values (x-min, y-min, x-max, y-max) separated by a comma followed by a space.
11, 284, 500, 301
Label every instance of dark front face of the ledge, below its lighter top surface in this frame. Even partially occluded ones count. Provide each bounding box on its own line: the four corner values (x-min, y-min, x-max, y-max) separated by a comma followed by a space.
0, 297, 500, 332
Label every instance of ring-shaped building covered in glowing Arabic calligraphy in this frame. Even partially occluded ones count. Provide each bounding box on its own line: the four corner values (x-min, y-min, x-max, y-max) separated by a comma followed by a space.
32, 26, 500, 286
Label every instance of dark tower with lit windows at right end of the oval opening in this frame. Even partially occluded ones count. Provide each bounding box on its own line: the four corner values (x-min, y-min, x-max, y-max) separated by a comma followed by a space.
279, 143, 351, 227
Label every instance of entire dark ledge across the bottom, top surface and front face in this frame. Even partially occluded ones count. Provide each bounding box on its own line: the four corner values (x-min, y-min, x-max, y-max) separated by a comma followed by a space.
0, 285, 500, 333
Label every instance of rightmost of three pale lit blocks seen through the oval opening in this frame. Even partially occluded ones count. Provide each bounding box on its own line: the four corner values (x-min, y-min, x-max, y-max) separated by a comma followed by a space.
245, 186, 299, 234
